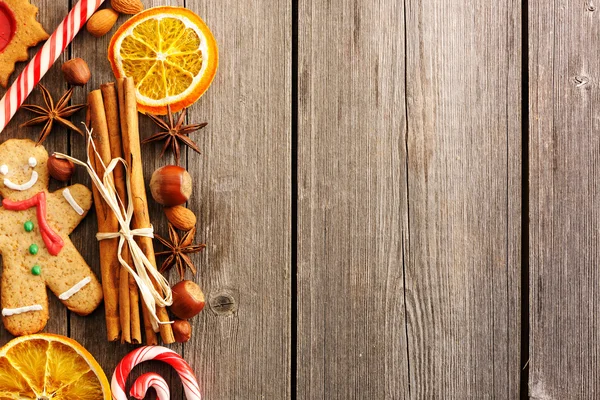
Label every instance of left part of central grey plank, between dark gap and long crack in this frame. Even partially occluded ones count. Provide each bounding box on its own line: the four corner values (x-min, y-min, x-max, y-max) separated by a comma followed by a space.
297, 0, 410, 399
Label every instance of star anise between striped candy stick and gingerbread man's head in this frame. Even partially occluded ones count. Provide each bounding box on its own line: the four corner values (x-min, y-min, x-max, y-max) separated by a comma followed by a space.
21, 84, 87, 145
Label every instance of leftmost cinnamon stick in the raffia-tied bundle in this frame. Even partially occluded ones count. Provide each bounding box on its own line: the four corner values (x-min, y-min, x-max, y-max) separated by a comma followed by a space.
88, 90, 121, 342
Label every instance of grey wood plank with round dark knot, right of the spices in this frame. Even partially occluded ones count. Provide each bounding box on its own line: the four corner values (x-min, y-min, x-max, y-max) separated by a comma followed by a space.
184, 0, 291, 400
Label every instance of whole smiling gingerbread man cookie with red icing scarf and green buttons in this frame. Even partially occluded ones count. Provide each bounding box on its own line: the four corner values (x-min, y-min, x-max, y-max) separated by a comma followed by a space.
0, 139, 102, 336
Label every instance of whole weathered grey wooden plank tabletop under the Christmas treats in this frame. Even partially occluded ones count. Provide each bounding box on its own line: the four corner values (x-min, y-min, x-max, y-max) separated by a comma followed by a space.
0, 0, 600, 400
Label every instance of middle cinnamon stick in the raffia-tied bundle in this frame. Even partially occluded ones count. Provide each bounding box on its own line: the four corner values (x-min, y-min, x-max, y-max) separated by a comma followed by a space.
100, 82, 142, 344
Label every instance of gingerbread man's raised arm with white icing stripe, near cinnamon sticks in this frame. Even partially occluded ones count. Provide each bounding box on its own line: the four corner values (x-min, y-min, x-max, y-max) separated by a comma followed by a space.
46, 184, 92, 235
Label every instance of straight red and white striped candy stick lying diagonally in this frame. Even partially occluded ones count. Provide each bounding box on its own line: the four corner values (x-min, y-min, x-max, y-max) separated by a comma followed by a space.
0, 0, 104, 133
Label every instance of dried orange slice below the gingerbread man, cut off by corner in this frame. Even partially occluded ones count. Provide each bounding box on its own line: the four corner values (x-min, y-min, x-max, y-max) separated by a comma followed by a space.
0, 333, 111, 400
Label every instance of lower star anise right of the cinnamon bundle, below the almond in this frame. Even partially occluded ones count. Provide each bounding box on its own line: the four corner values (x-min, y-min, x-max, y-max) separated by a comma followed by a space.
154, 223, 206, 279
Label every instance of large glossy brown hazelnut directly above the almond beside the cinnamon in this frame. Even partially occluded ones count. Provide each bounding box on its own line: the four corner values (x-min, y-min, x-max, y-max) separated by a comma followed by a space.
150, 165, 192, 207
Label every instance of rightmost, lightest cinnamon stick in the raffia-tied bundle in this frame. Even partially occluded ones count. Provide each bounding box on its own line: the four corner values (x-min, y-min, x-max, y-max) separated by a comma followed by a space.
118, 78, 175, 344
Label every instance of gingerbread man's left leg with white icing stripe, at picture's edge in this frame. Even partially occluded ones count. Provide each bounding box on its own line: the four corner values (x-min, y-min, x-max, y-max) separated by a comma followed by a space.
2, 254, 48, 336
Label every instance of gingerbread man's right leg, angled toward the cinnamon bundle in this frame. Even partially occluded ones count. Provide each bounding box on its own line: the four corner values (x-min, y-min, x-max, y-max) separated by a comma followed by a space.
43, 239, 102, 315
